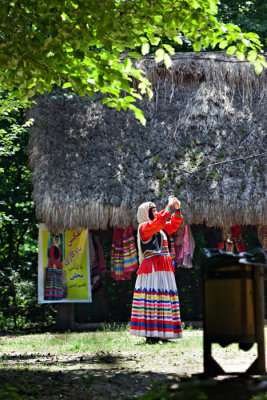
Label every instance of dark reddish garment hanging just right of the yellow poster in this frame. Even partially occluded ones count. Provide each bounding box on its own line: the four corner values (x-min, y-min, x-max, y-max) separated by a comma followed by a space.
89, 232, 107, 290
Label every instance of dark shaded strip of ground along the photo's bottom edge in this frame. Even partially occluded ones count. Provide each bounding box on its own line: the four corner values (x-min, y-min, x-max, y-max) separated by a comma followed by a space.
0, 363, 267, 400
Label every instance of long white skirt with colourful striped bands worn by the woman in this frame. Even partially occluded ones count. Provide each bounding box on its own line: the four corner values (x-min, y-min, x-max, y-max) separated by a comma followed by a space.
130, 267, 182, 339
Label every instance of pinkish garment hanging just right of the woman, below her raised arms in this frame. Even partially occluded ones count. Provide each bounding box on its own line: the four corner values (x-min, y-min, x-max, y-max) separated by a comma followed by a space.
173, 224, 195, 268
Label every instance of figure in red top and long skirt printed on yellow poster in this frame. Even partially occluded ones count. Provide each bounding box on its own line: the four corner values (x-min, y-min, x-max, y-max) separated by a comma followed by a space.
44, 241, 63, 300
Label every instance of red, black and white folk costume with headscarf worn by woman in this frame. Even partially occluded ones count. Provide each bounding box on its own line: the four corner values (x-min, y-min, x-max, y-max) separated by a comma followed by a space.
130, 202, 183, 339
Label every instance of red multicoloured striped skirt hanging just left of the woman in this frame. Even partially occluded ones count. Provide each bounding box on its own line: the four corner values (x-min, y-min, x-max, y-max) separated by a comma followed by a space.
111, 226, 138, 280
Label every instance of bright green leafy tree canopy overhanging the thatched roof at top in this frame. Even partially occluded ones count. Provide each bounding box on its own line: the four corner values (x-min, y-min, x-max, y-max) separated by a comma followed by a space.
0, 0, 266, 123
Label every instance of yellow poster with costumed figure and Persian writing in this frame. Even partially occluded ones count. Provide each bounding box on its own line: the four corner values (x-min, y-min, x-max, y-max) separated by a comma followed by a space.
38, 224, 92, 303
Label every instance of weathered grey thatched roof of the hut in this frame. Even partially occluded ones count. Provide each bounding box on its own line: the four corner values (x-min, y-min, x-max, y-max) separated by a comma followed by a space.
29, 52, 267, 231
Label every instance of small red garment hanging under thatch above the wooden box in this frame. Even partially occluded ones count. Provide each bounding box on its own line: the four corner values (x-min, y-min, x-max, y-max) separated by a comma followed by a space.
219, 225, 246, 254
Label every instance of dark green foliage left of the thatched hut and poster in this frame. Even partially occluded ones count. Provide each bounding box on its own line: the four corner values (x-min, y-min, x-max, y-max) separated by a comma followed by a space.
0, 94, 55, 330
